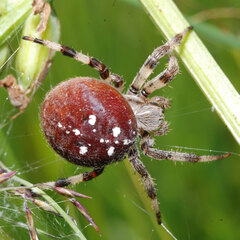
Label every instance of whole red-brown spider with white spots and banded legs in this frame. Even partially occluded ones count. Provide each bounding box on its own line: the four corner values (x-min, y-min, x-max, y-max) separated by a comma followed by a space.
23, 26, 230, 224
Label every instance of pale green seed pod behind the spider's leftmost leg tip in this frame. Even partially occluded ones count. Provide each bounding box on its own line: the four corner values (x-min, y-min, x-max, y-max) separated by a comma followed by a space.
16, 10, 60, 91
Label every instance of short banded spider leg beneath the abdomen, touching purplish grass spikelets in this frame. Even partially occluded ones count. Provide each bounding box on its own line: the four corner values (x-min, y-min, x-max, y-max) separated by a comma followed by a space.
46, 167, 104, 187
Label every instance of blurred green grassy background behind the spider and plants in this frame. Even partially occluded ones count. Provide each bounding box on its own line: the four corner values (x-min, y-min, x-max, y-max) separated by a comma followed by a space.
0, 0, 240, 240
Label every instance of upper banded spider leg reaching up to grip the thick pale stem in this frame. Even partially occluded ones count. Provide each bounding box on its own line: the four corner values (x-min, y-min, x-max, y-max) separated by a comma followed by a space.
128, 26, 192, 94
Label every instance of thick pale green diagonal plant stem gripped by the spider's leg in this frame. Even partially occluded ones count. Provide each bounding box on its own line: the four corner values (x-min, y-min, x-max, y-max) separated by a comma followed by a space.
139, 0, 240, 144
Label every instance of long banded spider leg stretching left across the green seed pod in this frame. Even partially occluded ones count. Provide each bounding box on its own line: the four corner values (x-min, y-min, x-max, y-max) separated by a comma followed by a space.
23, 36, 123, 88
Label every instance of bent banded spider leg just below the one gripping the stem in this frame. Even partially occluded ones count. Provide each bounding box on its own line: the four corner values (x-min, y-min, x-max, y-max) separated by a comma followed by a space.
141, 52, 179, 97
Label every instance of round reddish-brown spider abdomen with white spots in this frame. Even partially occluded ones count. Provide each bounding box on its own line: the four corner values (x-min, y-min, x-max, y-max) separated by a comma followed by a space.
41, 77, 137, 167
